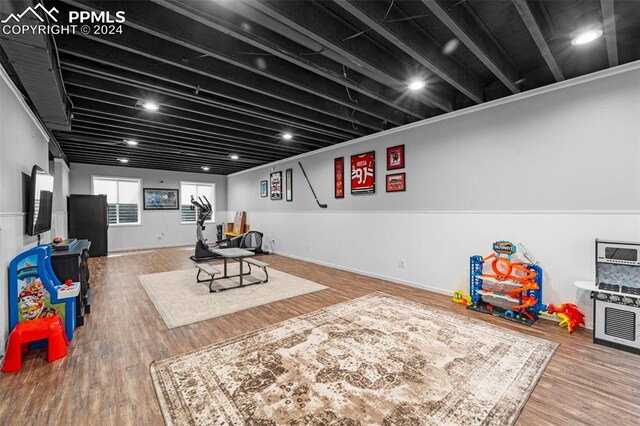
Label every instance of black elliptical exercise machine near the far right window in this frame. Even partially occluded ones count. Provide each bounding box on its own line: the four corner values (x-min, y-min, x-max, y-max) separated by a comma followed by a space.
190, 195, 267, 262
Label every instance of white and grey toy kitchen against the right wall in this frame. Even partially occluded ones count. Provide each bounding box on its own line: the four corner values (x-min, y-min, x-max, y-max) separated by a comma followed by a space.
575, 240, 640, 354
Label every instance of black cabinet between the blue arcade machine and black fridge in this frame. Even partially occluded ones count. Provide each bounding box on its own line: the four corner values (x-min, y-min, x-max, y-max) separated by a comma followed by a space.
51, 240, 92, 327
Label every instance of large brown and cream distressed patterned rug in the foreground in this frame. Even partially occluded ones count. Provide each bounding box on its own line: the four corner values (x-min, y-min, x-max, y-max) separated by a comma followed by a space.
151, 293, 558, 425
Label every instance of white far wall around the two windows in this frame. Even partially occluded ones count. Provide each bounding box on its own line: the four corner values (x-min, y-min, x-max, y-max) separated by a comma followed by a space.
69, 163, 227, 251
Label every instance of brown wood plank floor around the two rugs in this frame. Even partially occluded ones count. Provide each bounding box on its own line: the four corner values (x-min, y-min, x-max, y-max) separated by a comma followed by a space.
0, 248, 640, 425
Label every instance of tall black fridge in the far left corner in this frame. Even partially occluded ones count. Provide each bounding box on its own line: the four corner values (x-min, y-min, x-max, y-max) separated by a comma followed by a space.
68, 195, 109, 257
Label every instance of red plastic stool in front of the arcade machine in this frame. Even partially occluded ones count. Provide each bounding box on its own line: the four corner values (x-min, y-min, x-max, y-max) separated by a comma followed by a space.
2, 315, 69, 373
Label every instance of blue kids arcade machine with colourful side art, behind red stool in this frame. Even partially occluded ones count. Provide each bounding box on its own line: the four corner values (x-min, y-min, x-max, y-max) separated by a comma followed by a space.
9, 245, 80, 348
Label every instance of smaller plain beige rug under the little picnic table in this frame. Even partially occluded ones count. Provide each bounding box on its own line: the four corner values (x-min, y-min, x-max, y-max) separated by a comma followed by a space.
138, 262, 327, 328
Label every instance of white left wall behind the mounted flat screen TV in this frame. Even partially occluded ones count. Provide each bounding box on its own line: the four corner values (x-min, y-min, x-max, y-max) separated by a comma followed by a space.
0, 67, 50, 354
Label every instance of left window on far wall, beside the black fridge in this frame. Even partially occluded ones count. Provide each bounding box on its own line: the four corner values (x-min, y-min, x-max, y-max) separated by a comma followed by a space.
92, 177, 140, 225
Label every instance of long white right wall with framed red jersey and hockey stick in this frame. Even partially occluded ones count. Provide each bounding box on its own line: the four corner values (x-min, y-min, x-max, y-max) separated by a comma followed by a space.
227, 63, 640, 326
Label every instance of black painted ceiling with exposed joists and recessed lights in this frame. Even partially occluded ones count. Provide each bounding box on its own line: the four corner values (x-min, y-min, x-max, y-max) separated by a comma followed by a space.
45, 0, 640, 174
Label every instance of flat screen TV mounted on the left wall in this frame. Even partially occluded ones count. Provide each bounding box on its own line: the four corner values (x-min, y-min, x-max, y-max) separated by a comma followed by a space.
27, 166, 53, 235
